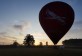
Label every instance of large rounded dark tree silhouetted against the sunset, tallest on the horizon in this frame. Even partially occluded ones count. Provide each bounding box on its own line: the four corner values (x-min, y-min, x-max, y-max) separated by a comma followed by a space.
24, 34, 35, 46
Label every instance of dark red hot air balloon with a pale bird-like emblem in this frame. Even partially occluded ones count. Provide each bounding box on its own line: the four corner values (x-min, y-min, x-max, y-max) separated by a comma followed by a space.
39, 1, 74, 44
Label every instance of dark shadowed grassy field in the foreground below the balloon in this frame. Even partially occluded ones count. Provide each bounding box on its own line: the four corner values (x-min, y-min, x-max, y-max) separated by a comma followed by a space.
0, 47, 82, 56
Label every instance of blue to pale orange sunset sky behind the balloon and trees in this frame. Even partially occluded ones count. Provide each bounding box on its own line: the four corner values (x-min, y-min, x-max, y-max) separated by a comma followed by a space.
0, 0, 82, 45
